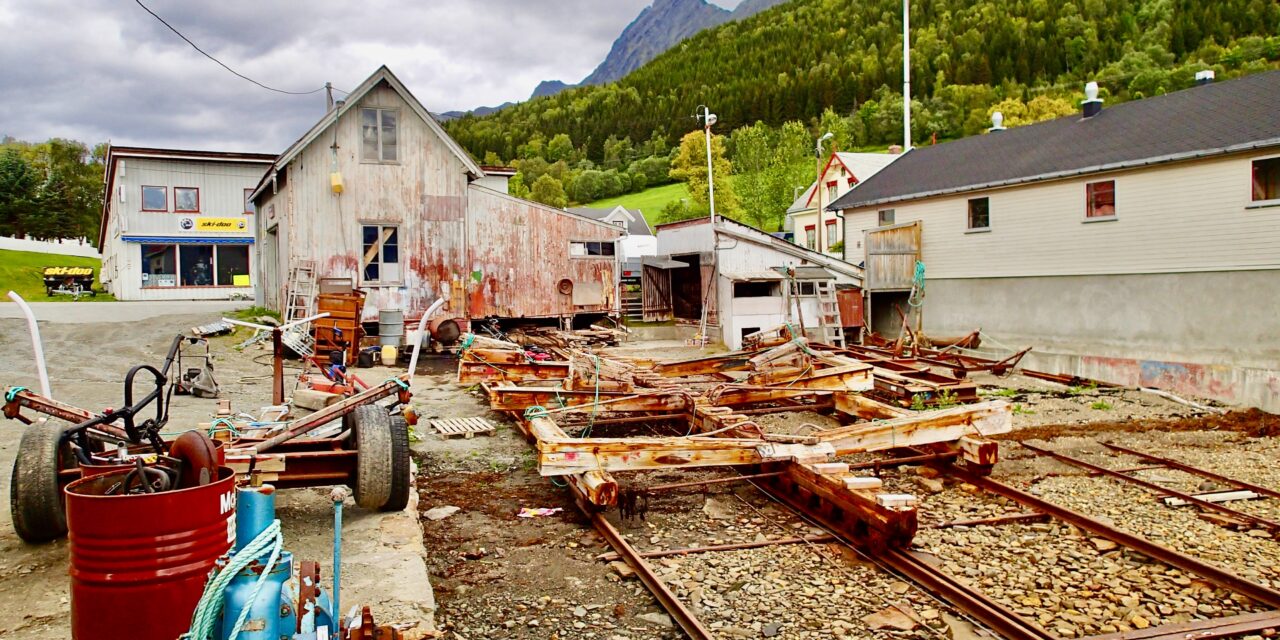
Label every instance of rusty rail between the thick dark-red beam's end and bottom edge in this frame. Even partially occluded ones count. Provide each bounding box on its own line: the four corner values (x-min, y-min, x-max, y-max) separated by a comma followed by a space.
877, 549, 1057, 640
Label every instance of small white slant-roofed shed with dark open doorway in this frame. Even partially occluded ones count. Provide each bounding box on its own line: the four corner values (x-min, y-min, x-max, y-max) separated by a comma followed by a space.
643, 218, 861, 349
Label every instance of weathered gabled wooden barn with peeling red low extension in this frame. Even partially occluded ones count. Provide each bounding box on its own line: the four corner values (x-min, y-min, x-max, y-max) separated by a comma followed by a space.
253, 67, 622, 329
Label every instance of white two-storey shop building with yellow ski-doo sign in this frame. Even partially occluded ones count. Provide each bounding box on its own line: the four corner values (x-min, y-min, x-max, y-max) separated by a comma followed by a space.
99, 146, 275, 300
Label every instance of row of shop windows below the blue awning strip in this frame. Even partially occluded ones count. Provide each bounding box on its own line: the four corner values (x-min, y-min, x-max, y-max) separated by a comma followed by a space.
142, 244, 251, 287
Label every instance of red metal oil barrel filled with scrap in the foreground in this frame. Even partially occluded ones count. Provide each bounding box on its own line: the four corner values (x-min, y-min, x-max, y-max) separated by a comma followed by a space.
67, 467, 236, 640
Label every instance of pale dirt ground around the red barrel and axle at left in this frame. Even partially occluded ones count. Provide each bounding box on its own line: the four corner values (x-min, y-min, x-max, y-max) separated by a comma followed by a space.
0, 303, 434, 639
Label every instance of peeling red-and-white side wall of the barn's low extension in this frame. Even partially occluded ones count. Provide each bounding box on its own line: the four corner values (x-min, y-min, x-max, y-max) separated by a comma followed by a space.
466, 184, 621, 317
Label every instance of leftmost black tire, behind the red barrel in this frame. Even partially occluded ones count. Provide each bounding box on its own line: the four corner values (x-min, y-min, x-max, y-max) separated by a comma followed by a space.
9, 422, 67, 544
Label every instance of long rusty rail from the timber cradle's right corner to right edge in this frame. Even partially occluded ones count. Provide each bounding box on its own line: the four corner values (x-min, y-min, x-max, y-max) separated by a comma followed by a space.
943, 466, 1280, 608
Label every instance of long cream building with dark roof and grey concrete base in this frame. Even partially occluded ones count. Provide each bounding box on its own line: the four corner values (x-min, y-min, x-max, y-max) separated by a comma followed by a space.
828, 72, 1280, 411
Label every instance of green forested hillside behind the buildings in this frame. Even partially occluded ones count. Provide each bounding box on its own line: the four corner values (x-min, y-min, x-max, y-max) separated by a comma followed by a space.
447, 0, 1280, 163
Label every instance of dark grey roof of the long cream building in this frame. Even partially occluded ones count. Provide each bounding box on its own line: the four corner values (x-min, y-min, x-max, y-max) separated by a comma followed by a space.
827, 72, 1280, 210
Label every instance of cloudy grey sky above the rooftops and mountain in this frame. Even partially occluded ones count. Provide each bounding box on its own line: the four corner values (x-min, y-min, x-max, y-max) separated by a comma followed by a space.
0, 0, 741, 154
